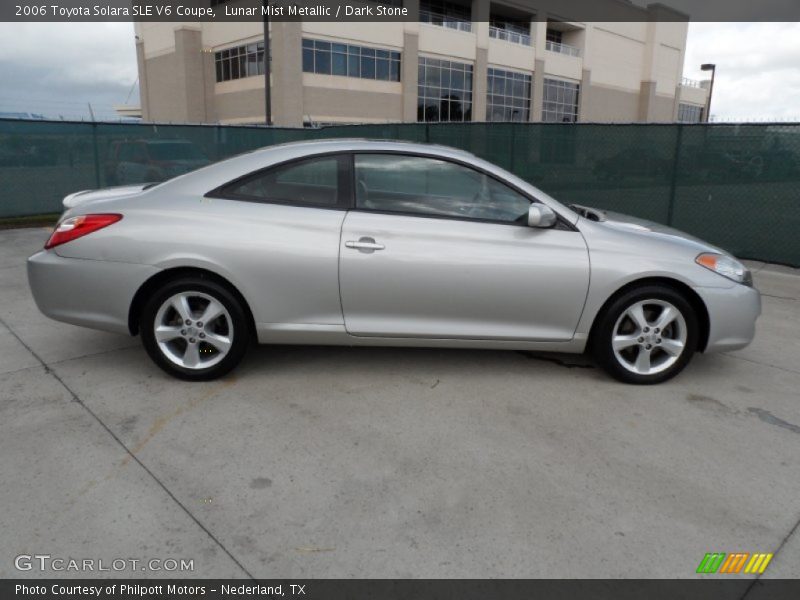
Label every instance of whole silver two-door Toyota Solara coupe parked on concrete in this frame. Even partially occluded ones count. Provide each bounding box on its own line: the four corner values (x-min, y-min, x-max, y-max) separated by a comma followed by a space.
28, 140, 761, 383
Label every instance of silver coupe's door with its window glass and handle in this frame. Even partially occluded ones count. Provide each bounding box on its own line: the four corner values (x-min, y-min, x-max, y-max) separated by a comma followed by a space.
339, 153, 589, 341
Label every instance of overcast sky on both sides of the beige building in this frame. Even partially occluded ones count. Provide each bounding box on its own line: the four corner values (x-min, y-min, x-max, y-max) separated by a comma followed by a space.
0, 23, 800, 120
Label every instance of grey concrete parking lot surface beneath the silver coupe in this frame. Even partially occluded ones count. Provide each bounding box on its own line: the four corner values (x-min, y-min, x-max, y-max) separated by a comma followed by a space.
0, 229, 800, 578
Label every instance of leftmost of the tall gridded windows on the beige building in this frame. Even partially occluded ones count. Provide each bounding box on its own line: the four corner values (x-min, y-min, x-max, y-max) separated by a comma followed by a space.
417, 57, 472, 121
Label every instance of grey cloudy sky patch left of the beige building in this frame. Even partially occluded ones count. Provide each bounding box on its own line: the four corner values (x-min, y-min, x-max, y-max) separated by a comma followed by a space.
0, 23, 139, 118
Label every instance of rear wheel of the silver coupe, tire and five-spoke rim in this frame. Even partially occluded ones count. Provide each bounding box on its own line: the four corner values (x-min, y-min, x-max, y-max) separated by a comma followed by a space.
139, 277, 250, 381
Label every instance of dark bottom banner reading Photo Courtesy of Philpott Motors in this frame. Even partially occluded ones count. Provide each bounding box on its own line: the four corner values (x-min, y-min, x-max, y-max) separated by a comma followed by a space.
0, 578, 800, 600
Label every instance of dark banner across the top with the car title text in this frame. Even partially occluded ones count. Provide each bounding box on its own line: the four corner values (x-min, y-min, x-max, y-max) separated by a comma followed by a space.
0, 0, 800, 22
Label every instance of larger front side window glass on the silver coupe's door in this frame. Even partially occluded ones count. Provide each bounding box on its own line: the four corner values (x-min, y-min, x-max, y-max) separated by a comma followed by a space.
355, 154, 530, 223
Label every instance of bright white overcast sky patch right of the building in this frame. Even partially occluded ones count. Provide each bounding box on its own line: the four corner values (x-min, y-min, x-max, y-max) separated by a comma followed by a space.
684, 23, 800, 121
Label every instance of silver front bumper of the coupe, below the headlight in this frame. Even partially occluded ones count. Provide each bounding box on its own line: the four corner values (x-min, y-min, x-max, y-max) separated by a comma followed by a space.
695, 284, 761, 353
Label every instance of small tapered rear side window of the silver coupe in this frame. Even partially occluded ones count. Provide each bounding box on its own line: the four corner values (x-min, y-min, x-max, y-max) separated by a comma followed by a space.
222, 156, 346, 206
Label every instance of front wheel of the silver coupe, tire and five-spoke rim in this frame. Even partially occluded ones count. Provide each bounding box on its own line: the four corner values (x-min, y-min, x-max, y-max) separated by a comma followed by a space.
591, 285, 698, 385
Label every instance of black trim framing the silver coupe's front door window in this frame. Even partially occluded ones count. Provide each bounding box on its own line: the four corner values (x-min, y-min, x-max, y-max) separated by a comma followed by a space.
350, 150, 578, 231
